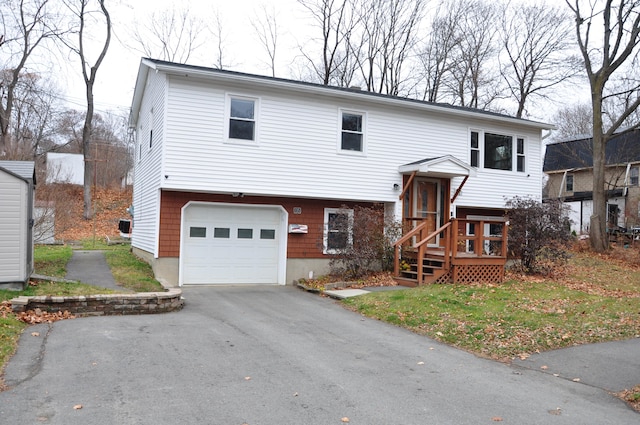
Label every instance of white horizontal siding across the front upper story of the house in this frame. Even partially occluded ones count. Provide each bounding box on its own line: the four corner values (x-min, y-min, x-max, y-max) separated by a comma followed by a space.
134, 71, 542, 217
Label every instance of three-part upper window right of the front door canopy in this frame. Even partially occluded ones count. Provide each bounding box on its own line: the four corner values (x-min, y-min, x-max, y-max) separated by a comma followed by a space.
469, 130, 526, 173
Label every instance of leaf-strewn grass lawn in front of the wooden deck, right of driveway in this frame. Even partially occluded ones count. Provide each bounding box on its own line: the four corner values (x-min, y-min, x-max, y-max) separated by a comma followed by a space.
344, 250, 640, 361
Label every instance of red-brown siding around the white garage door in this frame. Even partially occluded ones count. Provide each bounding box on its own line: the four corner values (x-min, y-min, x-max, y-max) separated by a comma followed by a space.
158, 191, 382, 258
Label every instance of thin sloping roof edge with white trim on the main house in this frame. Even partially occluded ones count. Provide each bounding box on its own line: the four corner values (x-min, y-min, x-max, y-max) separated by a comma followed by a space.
129, 58, 555, 130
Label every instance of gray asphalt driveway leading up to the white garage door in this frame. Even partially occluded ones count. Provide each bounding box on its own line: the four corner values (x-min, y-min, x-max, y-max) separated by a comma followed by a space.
0, 286, 640, 425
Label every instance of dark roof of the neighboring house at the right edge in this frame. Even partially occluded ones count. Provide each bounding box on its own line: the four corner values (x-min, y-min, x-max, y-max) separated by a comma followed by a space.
542, 130, 640, 173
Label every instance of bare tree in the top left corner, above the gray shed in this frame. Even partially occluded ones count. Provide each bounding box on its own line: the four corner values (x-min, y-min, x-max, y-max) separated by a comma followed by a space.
0, 0, 65, 154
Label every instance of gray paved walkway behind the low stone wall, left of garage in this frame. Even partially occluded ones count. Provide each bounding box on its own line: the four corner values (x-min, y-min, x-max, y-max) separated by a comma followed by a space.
65, 250, 129, 292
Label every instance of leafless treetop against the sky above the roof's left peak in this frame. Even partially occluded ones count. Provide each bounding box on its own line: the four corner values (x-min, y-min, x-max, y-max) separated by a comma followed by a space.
131, 4, 207, 63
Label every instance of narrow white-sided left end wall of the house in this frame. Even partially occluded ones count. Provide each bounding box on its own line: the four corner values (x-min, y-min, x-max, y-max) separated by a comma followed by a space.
131, 72, 166, 254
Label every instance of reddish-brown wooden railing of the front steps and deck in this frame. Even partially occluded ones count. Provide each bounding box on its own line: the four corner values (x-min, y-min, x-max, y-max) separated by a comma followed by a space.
393, 217, 508, 285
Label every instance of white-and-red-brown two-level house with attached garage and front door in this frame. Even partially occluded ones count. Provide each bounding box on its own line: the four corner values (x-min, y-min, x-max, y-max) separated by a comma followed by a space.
130, 59, 550, 285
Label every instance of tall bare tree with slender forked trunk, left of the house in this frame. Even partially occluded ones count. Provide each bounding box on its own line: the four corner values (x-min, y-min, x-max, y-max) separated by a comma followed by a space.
65, 0, 111, 220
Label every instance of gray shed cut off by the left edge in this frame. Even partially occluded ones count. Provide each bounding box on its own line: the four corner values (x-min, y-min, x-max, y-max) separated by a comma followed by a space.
0, 161, 36, 289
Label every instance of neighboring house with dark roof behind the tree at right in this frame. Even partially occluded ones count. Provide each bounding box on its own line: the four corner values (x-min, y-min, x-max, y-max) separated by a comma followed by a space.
543, 130, 640, 234
